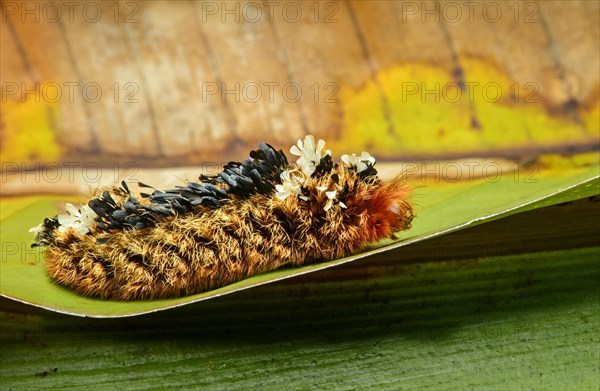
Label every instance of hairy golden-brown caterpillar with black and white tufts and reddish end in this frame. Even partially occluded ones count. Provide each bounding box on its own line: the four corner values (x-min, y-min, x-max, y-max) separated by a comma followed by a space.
30, 135, 413, 300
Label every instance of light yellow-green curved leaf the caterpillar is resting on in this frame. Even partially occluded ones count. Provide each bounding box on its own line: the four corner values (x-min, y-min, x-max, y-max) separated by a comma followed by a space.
0, 166, 600, 317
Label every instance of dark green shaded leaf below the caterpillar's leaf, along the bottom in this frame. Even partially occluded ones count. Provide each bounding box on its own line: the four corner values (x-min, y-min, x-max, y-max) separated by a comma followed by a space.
0, 200, 600, 390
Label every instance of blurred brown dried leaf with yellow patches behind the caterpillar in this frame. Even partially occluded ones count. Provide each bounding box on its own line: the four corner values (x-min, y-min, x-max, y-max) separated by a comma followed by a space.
0, 1, 600, 195
